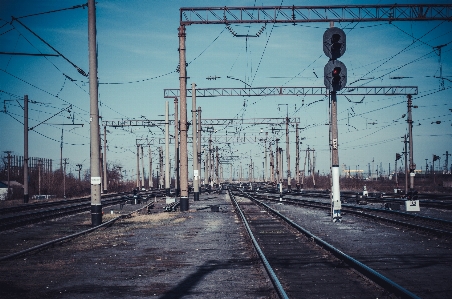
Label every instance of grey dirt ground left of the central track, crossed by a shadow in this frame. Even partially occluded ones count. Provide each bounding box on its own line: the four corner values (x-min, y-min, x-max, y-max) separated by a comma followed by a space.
0, 195, 277, 298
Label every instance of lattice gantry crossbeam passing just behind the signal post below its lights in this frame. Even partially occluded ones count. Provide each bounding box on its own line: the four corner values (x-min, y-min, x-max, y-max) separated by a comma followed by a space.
163, 86, 418, 98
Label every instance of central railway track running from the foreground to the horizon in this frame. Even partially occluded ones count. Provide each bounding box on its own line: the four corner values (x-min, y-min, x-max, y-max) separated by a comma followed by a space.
230, 191, 418, 298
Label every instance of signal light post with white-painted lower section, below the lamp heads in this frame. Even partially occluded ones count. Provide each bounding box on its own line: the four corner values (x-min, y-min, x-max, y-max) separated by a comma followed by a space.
328, 91, 341, 221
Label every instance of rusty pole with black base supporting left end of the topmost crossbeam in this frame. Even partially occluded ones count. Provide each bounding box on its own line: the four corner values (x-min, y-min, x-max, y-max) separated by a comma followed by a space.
178, 25, 189, 211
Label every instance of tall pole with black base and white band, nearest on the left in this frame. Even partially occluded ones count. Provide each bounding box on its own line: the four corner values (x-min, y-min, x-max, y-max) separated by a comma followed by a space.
88, 0, 102, 226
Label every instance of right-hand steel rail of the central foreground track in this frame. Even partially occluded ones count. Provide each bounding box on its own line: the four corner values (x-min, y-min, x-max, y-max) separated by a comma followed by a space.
242, 192, 420, 299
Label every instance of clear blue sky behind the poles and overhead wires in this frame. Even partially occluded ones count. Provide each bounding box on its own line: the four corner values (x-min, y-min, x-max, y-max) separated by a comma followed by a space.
0, 0, 452, 182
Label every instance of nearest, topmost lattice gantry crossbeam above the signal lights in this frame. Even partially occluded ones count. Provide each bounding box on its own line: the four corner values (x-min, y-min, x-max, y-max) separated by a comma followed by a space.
180, 4, 452, 26
